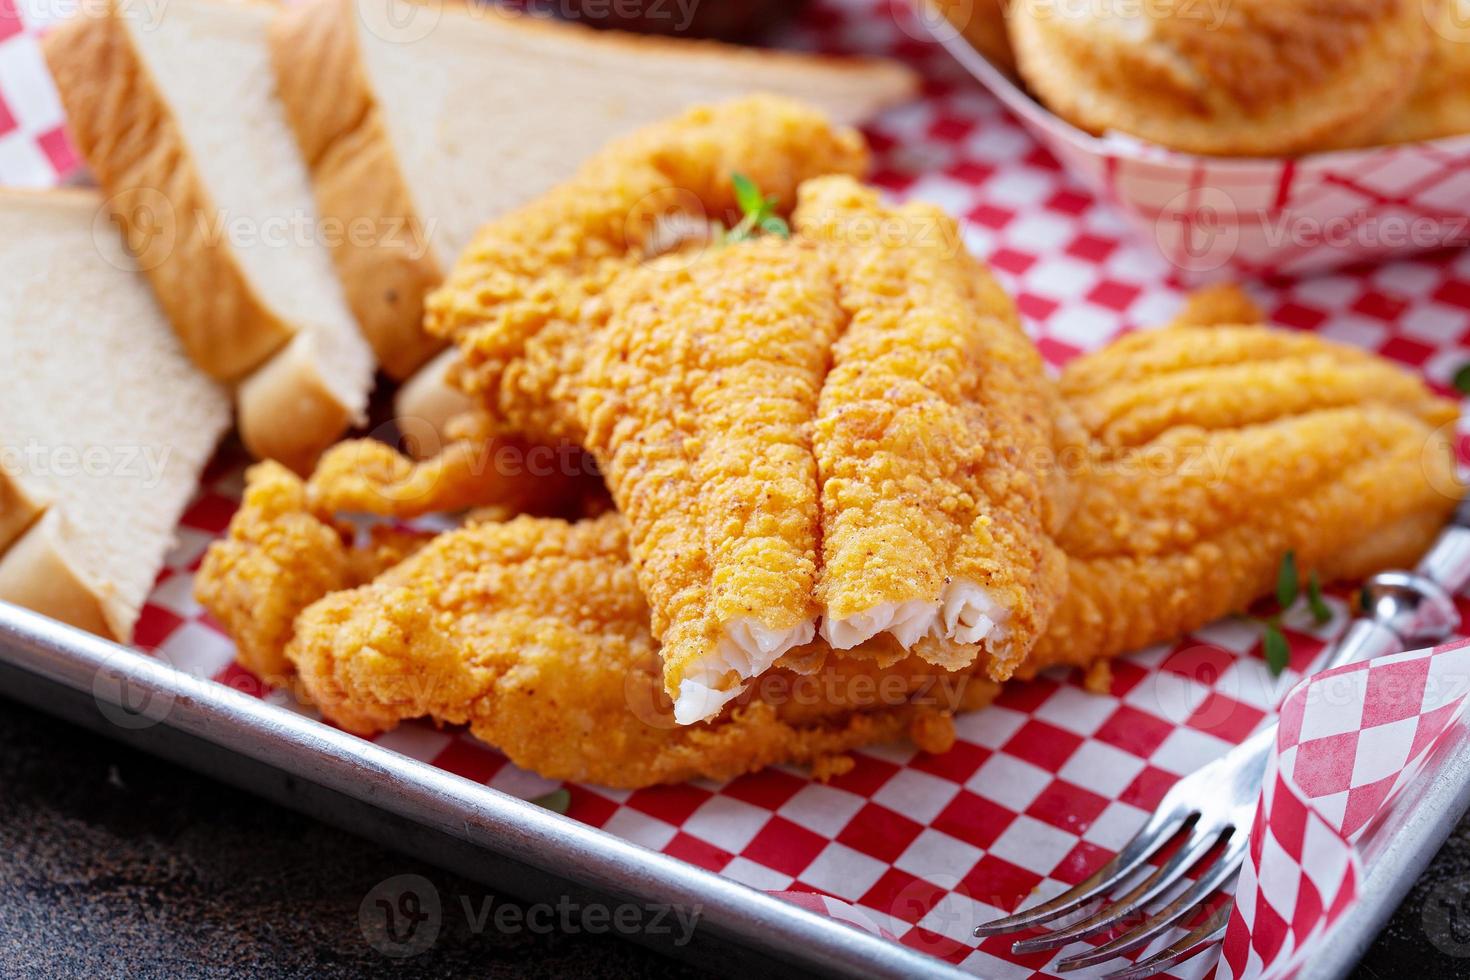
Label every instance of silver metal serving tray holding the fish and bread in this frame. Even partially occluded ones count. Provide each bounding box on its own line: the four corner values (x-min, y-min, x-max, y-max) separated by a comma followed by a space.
0, 602, 1470, 980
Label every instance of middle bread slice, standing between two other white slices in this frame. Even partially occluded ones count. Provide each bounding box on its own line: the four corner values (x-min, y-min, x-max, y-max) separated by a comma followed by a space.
46, 0, 373, 470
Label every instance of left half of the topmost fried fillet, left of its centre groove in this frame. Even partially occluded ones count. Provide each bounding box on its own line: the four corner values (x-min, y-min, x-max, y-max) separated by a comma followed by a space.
578, 238, 847, 723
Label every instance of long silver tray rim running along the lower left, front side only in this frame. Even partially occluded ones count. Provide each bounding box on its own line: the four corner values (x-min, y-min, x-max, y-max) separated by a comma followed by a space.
0, 601, 970, 980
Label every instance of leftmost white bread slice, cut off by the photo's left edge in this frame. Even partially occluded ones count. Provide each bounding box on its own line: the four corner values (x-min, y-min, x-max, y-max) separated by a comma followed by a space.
0, 191, 229, 642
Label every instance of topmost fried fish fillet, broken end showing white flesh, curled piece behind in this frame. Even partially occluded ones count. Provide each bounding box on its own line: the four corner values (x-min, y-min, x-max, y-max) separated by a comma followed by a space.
429, 97, 1064, 721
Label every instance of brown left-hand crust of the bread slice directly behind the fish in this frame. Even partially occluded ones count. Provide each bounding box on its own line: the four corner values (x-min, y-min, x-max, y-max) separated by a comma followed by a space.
270, 0, 441, 379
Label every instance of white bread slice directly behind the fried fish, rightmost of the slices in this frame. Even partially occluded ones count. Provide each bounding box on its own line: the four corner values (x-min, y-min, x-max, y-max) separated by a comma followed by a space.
270, 0, 917, 378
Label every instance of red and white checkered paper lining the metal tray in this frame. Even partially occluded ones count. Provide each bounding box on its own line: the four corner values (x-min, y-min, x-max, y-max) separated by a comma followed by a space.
0, 0, 1470, 977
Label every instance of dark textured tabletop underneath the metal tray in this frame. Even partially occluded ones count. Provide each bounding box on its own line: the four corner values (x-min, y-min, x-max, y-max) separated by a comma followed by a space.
0, 699, 1470, 979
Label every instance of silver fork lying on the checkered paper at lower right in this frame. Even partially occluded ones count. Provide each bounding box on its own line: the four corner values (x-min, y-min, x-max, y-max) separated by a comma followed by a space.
975, 500, 1470, 979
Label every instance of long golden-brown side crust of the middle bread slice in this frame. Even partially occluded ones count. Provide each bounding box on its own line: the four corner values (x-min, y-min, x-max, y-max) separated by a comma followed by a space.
43, 7, 293, 381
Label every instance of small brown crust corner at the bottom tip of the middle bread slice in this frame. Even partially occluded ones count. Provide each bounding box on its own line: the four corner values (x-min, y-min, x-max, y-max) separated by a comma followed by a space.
235, 336, 354, 473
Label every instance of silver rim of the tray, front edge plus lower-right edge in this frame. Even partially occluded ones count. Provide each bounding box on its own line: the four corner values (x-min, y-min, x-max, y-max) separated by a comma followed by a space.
0, 601, 1470, 980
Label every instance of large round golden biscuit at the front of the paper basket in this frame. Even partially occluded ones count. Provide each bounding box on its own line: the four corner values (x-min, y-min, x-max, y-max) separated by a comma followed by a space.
1010, 0, 1430, 156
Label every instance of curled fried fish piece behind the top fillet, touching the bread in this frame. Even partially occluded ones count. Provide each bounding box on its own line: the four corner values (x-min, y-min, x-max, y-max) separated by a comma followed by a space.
426, 96, 867, 444
